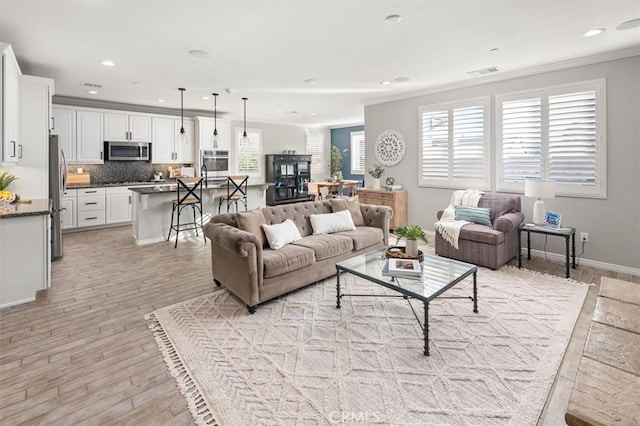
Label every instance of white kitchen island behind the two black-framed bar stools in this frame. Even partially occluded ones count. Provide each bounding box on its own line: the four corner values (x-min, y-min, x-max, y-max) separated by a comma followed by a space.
129, 181, 269, 245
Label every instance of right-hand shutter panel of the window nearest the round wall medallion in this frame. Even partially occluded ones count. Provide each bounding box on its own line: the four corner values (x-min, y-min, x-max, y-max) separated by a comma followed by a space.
453, 106, 485, 180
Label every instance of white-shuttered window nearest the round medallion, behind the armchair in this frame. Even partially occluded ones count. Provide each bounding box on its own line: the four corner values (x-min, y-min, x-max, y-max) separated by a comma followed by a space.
418, 98, 489, 189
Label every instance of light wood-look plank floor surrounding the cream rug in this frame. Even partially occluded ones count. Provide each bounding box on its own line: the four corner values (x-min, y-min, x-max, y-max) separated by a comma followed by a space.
0, 227, 640, 425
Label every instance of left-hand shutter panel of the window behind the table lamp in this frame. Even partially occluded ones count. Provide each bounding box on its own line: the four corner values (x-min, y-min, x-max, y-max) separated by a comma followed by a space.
501, 98, 542, 183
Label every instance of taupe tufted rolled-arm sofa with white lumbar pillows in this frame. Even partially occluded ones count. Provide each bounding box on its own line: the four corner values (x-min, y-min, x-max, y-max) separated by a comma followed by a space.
204, 199, 392, 313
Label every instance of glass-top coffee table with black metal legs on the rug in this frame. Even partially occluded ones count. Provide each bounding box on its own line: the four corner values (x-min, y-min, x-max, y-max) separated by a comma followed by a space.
336, 248, 478, 356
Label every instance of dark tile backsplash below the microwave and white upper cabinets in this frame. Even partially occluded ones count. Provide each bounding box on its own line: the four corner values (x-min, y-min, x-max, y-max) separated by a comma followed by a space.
67, 161, 191, 184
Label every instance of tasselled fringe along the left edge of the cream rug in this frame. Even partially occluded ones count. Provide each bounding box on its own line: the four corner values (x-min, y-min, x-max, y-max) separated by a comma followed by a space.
144, 313, 219, 426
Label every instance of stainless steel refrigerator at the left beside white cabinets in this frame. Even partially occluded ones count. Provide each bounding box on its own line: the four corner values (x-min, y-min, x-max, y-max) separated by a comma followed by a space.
49, 135, 67, 260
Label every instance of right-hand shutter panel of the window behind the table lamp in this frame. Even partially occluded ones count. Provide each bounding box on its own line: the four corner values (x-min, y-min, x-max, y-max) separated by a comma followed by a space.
549, 90, 598, 186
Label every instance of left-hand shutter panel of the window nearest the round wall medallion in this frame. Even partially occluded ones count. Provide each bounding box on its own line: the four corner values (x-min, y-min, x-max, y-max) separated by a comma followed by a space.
421, 111, 449, 181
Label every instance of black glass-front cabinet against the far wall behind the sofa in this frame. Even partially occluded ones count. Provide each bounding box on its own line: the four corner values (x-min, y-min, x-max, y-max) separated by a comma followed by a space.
265, 154, 314, 206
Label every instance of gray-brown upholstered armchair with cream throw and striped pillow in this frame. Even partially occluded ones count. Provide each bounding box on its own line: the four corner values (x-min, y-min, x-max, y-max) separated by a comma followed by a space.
435, 194, 524, 269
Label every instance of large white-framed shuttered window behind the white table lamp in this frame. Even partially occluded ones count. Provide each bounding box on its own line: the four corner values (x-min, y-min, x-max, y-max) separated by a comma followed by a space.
496, 80, 606, 198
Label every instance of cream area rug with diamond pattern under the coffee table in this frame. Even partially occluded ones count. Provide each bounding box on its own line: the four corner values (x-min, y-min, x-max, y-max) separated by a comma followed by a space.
148, 266, 588, 426
